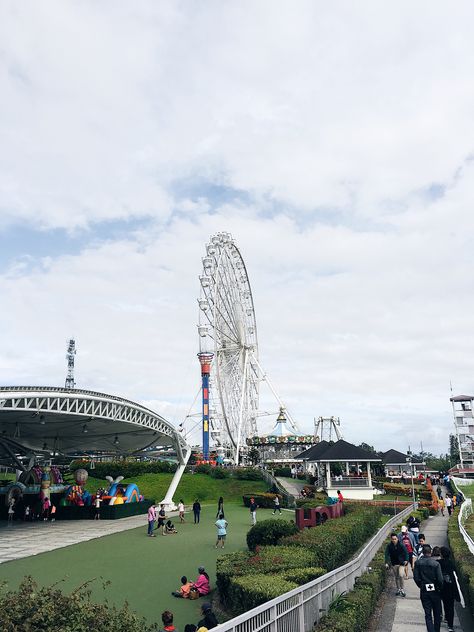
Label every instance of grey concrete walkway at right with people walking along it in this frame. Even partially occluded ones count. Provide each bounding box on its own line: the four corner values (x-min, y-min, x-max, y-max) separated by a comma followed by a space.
375, 510, 462, 632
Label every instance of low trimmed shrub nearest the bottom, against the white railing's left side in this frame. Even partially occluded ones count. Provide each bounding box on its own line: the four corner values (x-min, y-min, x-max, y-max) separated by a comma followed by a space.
228, 574, 297, 612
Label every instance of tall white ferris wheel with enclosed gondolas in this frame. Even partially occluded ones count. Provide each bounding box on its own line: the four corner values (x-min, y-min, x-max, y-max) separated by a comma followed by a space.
198, 233, 261, 463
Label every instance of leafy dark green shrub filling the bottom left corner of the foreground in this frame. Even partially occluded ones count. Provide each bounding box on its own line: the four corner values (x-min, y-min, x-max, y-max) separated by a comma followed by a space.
0, 577, 156, 632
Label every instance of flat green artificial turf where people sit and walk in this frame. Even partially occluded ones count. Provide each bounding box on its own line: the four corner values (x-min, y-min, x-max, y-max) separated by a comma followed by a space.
0, 504, 294, 630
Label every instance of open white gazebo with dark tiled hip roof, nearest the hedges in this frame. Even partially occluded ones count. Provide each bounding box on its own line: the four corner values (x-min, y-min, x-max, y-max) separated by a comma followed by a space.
296, 439, 382, 500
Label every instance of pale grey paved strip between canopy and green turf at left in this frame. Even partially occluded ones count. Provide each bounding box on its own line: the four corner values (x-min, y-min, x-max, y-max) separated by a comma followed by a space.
0, 514, 150, 564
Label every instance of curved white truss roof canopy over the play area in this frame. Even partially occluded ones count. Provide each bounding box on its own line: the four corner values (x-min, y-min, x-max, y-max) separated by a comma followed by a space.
0, 386, 188, 470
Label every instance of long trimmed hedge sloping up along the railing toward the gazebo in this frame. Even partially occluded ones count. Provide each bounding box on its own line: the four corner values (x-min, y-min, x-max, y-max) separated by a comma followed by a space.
281, 507, 381, 570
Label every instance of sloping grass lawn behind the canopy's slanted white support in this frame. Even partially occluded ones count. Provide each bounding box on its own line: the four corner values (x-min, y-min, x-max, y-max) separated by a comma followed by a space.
86, 473, 268, 507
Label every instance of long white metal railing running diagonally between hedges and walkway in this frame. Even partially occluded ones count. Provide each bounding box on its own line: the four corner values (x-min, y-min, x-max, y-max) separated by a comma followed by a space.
214, 505, 414, 632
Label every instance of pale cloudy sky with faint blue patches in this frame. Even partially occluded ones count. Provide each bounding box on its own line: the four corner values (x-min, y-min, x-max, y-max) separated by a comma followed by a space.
0, 0, 474, 454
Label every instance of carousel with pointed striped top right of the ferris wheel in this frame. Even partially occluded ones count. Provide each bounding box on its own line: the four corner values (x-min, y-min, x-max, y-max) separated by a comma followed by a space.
247, 408, 318, 465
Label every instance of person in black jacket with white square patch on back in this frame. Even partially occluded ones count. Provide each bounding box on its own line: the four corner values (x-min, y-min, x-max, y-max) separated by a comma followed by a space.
413, 544, 443, 632
